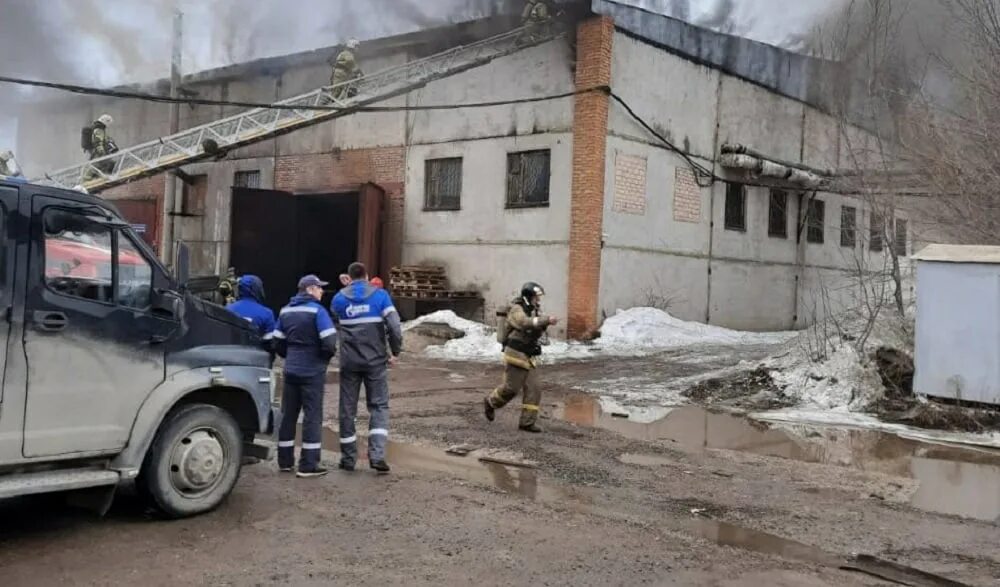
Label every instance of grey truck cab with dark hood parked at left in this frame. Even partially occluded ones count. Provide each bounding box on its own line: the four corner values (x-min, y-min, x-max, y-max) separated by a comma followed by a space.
0, 180, 276, 517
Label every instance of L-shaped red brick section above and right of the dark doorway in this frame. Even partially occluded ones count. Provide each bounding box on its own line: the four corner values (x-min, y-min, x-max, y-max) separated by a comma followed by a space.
274, 147, 406, 274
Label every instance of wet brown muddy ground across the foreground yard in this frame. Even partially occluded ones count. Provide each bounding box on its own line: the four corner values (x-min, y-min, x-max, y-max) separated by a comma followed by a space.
0, 351, 1000, 586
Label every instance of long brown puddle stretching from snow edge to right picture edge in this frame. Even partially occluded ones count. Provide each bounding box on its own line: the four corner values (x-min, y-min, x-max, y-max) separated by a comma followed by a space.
553, 395, 1000, 522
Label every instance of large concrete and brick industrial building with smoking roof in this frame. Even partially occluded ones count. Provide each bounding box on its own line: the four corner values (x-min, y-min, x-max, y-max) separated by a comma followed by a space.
17, 0, 911, 338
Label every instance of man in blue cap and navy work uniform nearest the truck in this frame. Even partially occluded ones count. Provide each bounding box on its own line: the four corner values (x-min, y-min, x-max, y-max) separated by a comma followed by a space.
274, 275, 337, 477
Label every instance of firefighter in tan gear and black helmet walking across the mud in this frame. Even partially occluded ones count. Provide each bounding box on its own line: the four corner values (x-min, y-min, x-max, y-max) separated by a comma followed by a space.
483, 281, 558, 432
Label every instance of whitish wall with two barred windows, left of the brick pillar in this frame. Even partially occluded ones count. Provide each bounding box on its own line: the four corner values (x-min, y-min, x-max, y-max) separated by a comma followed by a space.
403, 133, 573, 336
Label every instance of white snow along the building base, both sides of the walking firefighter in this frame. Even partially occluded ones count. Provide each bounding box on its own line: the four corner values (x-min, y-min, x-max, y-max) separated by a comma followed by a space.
403, 308, 795, 361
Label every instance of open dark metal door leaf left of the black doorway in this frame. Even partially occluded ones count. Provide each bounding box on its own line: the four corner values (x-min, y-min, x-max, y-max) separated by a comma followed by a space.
229, 188, 301, 312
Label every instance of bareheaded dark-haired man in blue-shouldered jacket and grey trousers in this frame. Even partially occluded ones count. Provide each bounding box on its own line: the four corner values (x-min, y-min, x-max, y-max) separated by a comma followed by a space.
332, 263, 403, 473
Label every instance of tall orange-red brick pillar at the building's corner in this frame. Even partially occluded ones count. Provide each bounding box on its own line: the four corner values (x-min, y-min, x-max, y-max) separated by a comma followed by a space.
567, 17, 614, 339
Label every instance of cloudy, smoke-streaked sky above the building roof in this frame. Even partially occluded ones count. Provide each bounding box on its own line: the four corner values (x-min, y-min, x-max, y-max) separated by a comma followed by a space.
0, 0, 842, 152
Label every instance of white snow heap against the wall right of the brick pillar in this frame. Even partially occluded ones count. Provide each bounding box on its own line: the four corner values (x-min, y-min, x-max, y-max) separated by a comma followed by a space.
597, 308, 796, 354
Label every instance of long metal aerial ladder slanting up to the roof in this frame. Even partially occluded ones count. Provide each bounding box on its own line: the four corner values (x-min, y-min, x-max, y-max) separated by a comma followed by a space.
33, 23, 563, 193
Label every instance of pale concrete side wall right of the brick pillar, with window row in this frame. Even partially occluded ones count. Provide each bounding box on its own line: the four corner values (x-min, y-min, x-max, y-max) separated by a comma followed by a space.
600, 33, 908, 330
